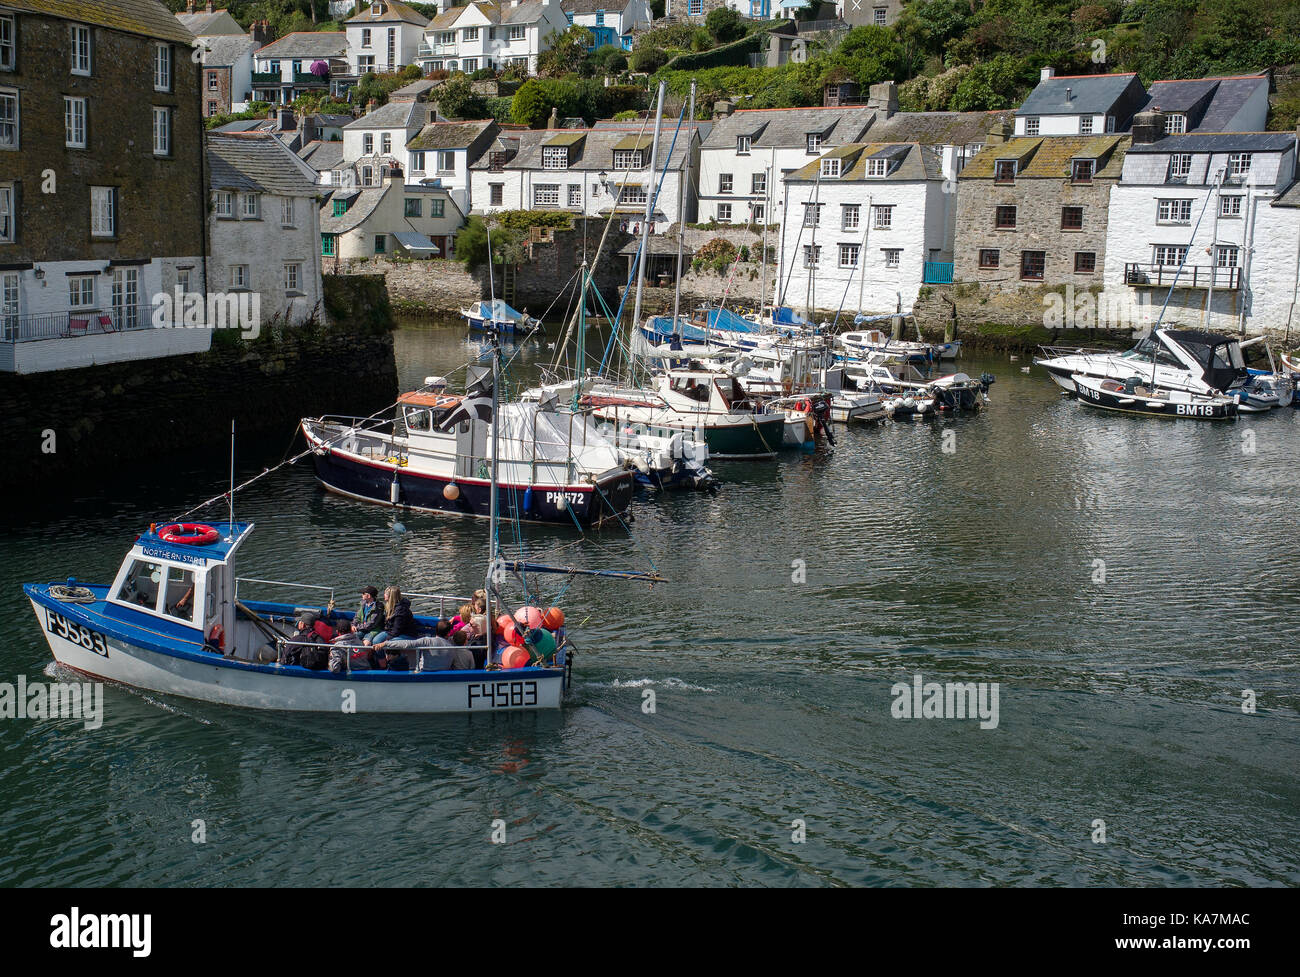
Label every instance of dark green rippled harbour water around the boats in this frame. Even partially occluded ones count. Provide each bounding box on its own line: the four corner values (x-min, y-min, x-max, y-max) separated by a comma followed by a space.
0, 324, 1300, 886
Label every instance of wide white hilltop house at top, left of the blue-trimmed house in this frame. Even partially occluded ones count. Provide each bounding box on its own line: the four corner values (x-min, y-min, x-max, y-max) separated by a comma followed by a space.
419, 0, 568, 74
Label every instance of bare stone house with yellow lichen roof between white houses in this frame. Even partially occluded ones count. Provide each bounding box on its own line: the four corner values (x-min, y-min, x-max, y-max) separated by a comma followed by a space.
953, 135, 1130, 291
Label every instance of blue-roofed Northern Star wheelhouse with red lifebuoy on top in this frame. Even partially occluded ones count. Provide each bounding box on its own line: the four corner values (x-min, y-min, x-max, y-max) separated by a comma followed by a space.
105, 522, 252, 648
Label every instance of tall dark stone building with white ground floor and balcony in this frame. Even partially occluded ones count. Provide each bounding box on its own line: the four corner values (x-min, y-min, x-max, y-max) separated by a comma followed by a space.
0, 0, 211, 372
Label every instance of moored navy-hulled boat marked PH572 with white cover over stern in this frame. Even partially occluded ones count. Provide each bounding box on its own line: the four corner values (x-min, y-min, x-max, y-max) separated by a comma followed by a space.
302, 391, 634, 527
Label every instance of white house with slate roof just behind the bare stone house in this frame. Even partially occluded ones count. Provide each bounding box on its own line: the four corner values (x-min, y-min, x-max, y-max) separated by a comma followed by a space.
1015, 68, 1147, 136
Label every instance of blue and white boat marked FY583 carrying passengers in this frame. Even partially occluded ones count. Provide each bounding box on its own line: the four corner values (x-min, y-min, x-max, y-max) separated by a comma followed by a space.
23, 522, 573, 715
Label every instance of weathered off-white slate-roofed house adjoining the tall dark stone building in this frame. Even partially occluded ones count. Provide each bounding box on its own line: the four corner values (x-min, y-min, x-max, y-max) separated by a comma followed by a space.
207, 133, 325, 327
